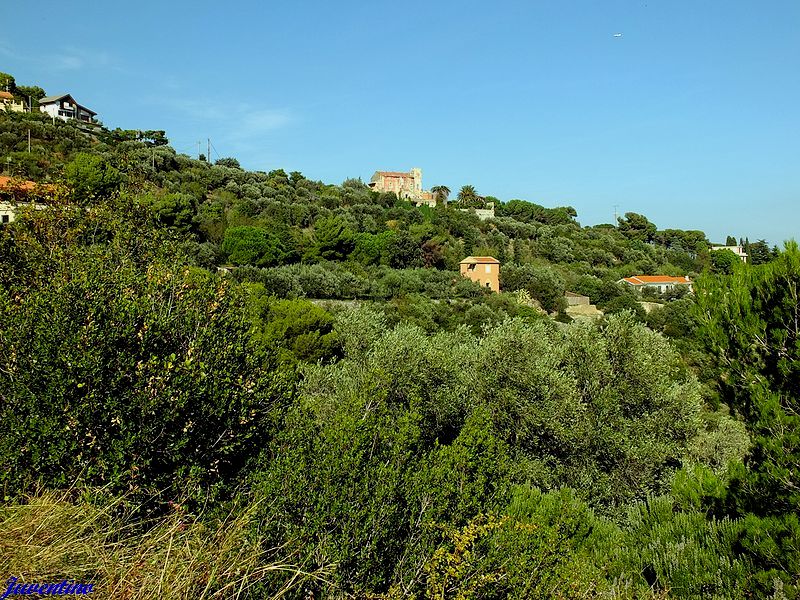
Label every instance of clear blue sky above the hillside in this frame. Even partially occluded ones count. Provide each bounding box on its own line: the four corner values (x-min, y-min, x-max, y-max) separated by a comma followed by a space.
0, 0, 800, 243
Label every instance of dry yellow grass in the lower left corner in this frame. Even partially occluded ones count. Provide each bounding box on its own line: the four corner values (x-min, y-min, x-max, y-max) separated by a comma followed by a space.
0, 492, 330, 600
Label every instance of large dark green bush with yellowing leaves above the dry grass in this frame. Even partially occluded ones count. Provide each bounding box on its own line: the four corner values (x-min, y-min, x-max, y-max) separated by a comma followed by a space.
0, 206, 288, 506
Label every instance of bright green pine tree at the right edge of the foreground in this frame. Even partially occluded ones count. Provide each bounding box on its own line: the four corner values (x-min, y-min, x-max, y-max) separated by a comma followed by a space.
698, 243, 800, 515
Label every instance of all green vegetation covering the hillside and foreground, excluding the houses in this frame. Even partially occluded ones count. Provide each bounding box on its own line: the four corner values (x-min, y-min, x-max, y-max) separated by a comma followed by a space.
0, 77, 800, 600
